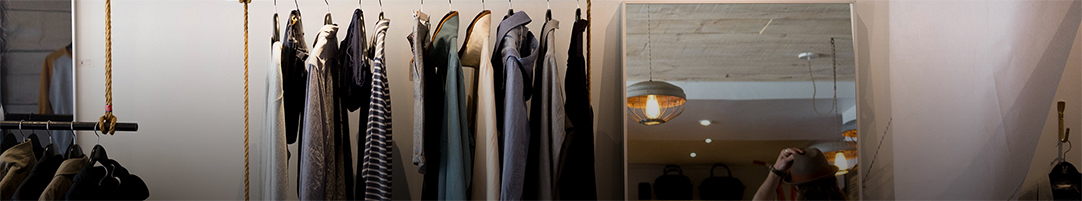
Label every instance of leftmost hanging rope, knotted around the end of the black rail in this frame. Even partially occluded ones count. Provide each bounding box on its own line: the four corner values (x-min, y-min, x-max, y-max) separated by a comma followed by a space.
97, 0, 117, 135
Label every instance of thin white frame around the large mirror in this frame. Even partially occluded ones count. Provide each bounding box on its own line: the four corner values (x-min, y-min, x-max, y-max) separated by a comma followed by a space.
618, 0, 868, 200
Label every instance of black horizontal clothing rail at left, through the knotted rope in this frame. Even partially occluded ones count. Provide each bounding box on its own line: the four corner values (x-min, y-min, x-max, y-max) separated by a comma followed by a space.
0, 113, 138, 132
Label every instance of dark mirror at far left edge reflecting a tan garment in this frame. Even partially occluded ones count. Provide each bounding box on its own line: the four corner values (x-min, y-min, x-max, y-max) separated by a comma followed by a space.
0, 0, 75, 153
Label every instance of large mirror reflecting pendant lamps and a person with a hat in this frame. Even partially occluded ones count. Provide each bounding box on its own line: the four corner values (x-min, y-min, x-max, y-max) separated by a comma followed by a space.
622, 2, 860, 200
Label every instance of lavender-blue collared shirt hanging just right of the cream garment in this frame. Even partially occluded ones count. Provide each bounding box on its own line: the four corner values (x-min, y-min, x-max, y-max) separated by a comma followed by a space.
492, 11, 538, 200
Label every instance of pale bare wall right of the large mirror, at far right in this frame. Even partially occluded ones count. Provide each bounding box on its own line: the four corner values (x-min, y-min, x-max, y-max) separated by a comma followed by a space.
881, 1, 1082, 200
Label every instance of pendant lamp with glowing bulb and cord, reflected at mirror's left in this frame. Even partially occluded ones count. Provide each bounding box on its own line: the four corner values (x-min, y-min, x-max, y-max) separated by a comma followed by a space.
628, 5, 687, 125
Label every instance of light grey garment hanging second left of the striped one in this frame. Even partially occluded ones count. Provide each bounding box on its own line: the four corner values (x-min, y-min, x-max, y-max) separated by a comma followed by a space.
298, 25, 346, 200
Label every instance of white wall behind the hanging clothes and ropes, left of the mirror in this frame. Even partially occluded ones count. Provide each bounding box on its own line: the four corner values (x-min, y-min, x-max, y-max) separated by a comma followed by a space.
75, 0, 624, 200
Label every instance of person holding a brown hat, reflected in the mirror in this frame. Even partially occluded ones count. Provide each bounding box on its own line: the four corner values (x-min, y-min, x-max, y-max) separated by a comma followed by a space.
752, 148, 846, 200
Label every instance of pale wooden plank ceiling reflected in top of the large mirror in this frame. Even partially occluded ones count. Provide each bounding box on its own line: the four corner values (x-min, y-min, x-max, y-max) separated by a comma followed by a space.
625, 3, 856, 81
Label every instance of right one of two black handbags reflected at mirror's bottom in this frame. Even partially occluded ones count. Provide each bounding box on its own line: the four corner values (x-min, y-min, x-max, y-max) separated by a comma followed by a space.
699, 163, 744, 200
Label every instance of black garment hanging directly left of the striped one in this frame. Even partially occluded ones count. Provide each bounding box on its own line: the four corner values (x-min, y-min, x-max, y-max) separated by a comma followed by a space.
334, 9, 372, 200
